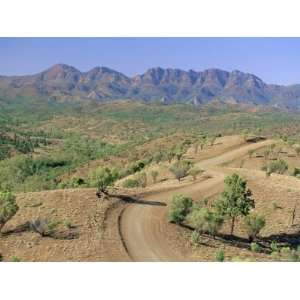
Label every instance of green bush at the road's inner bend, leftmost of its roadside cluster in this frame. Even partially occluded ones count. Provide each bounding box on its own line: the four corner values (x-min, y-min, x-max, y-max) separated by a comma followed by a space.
169, 194, 193, 224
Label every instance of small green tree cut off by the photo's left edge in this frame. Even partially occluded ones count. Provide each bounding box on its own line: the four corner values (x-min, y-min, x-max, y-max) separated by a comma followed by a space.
0, 192, 19, 234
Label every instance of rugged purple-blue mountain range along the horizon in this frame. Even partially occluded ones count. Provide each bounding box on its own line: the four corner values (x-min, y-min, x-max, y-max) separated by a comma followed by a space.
0, 64, 300, 109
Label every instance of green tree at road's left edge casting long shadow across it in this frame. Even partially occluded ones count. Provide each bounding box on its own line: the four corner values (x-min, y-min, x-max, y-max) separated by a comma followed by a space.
90, 167, 118, 198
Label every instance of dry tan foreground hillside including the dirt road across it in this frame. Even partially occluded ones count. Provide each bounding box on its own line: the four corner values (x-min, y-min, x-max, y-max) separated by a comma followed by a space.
0, 136, 300, 261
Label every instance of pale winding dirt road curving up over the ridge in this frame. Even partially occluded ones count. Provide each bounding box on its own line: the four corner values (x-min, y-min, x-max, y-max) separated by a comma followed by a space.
120, 140, 273, 261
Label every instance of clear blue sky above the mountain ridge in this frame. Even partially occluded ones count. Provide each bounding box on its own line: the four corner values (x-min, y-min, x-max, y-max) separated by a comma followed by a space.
0, 38, 300, 84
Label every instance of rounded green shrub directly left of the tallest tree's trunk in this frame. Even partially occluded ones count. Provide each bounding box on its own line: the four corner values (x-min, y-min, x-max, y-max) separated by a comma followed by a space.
187, 207, 223, 236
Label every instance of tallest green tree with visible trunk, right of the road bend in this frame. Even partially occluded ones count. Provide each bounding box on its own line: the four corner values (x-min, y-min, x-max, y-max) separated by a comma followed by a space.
216, 174, 255, 235
